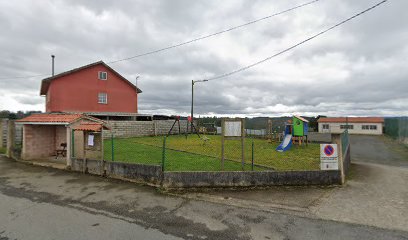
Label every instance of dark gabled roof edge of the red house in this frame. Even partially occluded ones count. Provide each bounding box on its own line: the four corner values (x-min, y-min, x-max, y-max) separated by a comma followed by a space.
40, 61, 142, 96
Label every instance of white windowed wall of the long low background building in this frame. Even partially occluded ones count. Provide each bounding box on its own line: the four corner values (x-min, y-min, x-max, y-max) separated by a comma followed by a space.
318, 122, 383, 135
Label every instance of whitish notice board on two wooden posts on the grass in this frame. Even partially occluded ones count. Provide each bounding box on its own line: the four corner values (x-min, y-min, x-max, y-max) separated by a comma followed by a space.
221, 118, 245, 171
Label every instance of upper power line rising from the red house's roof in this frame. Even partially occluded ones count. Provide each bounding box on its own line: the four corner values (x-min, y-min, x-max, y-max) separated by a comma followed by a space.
108, 0, 320, 63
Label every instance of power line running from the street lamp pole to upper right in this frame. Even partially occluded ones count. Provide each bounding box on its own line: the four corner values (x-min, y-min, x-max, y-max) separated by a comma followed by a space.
205, 0, 388, 81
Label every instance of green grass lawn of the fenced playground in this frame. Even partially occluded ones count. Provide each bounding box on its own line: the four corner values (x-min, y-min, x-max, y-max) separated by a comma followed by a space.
104, 135, 320, 171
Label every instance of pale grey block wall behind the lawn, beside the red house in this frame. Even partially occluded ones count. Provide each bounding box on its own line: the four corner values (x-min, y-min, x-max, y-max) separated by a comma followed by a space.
104, 120, 190, 138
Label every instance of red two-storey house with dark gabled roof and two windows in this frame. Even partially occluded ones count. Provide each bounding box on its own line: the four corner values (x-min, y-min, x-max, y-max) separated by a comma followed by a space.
40, 61, 142, 119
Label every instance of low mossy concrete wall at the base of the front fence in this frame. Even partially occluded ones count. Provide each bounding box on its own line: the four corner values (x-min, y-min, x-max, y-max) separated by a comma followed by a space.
71, 159, 342, 188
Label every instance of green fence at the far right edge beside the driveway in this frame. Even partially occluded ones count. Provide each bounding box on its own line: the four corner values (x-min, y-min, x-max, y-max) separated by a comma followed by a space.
384, 117, 408, 144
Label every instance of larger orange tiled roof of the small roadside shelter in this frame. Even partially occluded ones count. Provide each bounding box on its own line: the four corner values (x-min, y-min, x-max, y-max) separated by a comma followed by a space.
16, 114, 83, 124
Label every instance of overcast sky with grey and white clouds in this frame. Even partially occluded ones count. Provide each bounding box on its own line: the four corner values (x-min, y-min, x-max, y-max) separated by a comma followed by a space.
0, 0, 408, 117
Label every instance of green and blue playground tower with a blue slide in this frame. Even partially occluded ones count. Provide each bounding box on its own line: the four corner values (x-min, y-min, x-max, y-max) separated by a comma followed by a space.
276, 116, 309, 152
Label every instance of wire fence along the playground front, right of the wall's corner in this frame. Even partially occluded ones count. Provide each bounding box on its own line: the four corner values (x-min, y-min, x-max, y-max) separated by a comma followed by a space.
164, 134, 320, 171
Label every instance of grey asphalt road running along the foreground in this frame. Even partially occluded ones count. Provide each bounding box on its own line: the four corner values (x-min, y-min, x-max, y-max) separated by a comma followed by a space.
0, 156, 408, 240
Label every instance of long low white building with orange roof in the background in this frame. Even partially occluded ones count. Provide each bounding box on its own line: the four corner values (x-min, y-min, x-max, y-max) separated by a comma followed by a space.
317, 117, 384, 135
